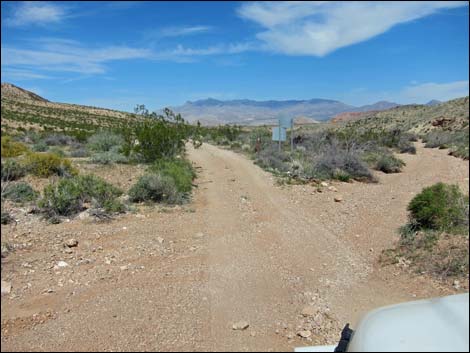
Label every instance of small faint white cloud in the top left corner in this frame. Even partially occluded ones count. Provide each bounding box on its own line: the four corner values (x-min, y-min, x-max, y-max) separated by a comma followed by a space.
5, 1, 68, 27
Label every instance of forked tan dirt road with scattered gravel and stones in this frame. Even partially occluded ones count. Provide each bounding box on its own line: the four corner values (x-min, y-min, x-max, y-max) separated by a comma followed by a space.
2, 144, 469, 351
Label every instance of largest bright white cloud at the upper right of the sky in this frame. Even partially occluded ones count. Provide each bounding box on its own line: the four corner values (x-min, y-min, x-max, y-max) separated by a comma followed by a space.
238, 1, 467, 56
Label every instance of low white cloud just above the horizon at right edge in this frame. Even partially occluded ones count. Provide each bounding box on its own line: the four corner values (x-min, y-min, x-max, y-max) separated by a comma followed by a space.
399, 81, 469, 103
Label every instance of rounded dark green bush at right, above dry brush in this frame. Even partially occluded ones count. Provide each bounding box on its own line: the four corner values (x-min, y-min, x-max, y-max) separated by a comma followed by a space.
408, 183, 468, 230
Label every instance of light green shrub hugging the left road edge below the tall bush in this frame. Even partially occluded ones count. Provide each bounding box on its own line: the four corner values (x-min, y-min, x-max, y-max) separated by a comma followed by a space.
150, 158, 196, 193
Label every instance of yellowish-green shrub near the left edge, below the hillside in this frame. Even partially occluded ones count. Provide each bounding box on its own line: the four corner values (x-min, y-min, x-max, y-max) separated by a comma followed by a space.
22, 153, 77, 177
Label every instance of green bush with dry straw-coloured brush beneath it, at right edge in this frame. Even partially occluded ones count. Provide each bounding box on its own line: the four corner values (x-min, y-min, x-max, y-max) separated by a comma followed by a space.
382, 183, 469, 279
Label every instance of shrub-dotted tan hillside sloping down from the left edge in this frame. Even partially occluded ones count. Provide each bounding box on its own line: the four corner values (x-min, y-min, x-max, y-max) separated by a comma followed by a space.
1, 83, 139, 132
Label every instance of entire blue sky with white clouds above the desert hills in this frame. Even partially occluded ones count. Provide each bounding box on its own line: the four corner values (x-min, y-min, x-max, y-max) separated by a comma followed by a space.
1, 1, 469, 111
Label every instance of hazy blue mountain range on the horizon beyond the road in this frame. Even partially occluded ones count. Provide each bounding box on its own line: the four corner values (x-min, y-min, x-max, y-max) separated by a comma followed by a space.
171, 98, 398, 125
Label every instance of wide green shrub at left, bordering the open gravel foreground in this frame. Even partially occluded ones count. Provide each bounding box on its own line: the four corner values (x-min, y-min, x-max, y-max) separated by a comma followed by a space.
38, 175, 122, 217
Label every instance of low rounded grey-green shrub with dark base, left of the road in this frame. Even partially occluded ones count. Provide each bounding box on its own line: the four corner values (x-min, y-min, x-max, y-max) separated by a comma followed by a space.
129, 173, 183, 204
